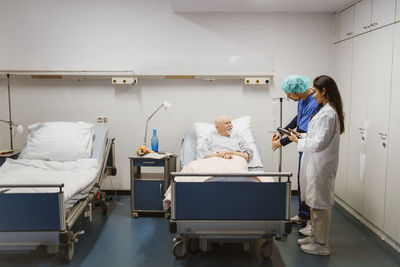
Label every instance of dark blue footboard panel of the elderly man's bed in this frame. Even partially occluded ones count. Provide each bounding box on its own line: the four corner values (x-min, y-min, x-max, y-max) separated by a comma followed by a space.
172, 182, 290, 220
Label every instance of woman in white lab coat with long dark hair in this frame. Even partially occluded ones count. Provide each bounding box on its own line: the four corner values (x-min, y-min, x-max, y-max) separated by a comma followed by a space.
289, 75, 344, 255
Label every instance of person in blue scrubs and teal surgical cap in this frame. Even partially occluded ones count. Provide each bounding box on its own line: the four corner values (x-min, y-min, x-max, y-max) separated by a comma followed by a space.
272, 75, 318, 236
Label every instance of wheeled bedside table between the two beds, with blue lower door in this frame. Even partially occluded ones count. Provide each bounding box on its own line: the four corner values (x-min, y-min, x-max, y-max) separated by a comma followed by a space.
129, 155, 176, 218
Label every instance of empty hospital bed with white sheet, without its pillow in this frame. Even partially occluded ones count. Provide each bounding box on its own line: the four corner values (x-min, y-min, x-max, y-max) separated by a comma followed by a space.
0, 126, 116, 261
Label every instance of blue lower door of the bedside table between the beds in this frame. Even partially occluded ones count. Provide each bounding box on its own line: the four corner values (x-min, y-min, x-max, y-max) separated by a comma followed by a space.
133, 180, 164, 211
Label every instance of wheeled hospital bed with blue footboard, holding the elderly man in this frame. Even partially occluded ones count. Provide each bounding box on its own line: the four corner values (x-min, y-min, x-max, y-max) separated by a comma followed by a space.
170, 133, 292, 258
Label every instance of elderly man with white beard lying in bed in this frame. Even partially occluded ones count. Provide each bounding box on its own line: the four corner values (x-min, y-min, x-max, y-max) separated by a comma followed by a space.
198, 115, 254, 162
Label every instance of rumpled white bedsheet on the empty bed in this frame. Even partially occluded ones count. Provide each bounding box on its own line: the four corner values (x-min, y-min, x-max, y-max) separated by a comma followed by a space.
0, 158, 100, 210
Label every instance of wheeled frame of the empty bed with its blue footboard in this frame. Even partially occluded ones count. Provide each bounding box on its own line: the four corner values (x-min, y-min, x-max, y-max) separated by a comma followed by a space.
0, 138, 116, 262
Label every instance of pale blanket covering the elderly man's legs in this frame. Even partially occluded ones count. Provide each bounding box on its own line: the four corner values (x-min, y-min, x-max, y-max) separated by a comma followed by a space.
163, 156, 273, 210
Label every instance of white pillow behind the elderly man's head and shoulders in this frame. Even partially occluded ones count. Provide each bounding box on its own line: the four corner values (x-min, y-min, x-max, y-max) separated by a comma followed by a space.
193, 116, 263, 167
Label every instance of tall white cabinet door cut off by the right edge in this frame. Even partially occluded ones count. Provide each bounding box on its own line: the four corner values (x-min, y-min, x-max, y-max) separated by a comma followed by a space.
383, 24, 400, 243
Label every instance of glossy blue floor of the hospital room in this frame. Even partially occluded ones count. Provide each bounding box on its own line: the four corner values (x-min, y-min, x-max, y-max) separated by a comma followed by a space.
0, 197, 400, 267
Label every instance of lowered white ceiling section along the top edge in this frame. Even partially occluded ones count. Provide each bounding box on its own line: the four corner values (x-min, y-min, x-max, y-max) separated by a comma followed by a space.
170, 0, 358, 13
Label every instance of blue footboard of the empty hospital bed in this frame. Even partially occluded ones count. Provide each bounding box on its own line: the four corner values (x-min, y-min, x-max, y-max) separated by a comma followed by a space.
0, 185, 65, 250
